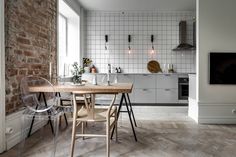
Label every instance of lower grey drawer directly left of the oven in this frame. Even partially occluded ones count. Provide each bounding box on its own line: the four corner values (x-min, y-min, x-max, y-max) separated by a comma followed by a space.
156, 89, 178, 103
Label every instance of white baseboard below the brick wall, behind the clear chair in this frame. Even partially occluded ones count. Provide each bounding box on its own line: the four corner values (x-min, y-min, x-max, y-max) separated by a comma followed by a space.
6, 111, 47, 150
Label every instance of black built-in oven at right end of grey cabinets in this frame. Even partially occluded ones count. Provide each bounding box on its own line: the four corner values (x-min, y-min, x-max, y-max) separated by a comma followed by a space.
178, 77, 189, 100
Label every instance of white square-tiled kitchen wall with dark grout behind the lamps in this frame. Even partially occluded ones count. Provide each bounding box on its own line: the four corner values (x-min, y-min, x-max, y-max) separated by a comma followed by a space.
85, 11, 196, 73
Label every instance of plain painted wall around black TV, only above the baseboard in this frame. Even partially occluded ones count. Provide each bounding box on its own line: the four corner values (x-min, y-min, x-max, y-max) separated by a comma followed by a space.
198, 0, 236, 103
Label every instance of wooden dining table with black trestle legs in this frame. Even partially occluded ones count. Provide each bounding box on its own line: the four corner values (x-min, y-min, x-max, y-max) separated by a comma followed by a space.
29, 83, 137, 141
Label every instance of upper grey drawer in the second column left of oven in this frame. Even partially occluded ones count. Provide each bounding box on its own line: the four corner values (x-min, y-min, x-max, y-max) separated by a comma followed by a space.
134, 74, 156, 89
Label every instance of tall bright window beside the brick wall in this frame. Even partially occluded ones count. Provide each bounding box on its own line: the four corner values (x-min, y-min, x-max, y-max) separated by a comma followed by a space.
58, 1, 80, 76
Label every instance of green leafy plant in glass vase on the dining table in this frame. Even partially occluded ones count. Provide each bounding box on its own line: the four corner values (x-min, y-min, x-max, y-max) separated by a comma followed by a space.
71, 62, 84, 84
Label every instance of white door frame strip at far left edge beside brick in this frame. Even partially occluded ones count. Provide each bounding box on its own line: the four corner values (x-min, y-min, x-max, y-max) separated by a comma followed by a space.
0, 0, 6, 153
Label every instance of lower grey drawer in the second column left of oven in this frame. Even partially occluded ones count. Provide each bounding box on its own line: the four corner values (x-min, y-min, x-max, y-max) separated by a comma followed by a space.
134, 89, 156, 103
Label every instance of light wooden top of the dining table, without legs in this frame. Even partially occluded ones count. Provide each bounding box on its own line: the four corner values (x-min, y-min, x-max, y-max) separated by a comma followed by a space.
29, 83, 133, 94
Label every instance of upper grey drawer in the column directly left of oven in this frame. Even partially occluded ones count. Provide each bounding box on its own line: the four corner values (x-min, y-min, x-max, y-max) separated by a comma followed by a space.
156, 74, 178, 89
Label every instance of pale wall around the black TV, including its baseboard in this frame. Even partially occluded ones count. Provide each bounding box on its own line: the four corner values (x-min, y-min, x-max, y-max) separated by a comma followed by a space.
197, 0, 236, 123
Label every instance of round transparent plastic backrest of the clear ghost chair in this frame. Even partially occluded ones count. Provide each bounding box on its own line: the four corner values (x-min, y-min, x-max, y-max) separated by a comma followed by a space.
20, 76, 58, 112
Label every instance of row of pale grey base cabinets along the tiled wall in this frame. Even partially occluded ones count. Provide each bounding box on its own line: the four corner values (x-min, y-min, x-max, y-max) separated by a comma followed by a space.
83, 74, 186, 104
